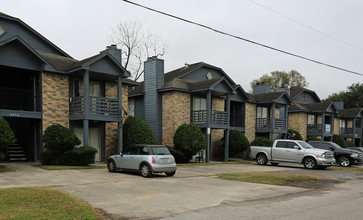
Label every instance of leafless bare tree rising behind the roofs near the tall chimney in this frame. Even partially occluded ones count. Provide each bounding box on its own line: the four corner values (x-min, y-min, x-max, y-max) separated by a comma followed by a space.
110, 21, 167, 81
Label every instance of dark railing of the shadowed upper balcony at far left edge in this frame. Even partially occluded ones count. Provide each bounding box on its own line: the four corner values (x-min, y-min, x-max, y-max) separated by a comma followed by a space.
0, 87, 36, 111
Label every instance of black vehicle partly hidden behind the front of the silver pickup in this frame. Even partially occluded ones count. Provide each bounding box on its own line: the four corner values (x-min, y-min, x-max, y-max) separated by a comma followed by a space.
309, 141, 363, 167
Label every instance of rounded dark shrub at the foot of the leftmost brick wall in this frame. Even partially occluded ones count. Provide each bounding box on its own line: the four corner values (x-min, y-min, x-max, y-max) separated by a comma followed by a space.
43, 124, 81, 155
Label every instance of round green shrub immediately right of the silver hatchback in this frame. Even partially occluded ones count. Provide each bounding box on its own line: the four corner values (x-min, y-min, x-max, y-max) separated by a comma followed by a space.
173, 124, 207, 160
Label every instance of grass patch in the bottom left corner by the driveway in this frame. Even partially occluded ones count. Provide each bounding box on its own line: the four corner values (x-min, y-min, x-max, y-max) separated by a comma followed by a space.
0, 188, 107, 219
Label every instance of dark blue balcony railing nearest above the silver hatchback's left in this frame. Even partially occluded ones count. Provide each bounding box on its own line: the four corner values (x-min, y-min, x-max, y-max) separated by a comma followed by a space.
69, 96, 119, 116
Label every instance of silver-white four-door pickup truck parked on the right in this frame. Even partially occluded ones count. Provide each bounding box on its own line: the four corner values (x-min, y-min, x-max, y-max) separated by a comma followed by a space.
250, 140, 335, 169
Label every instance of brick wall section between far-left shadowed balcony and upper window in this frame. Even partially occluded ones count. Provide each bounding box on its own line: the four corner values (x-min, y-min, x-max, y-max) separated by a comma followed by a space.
42, 73, 69, 131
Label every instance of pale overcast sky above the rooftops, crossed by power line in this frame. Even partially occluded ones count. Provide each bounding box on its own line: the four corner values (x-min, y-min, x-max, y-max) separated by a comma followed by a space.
0, 0, 363, 99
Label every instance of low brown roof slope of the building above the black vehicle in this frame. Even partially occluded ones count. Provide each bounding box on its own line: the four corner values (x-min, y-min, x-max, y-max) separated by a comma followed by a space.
289, 101, 336, 112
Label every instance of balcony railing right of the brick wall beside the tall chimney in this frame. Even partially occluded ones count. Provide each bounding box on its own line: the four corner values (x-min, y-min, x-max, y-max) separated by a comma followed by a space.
192, 110, 228, 125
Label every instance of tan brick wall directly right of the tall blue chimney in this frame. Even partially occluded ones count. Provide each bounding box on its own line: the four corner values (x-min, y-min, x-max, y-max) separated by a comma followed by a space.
162, 91, 191, 146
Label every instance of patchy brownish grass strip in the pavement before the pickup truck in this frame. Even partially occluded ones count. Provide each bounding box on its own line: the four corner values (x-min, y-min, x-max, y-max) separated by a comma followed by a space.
218, 172, 328, 187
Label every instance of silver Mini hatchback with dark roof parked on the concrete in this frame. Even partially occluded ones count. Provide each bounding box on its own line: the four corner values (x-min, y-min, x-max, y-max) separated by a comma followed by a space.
107, 144, 176, 177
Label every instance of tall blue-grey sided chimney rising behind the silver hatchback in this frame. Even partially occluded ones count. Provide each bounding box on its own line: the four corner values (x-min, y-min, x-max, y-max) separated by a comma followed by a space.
144, 57, 164, 144
